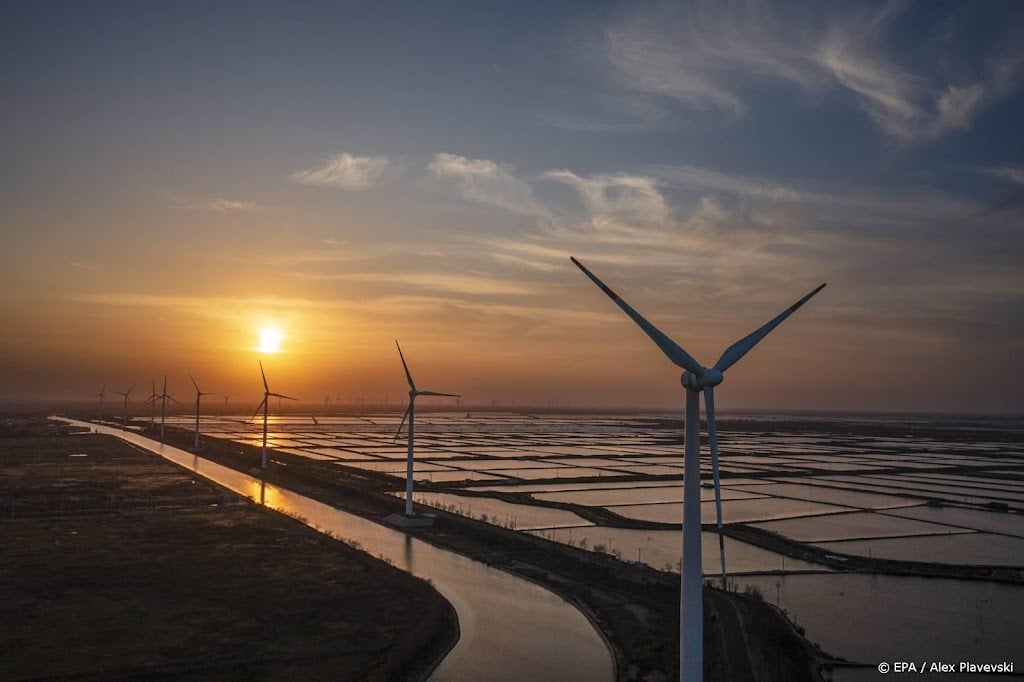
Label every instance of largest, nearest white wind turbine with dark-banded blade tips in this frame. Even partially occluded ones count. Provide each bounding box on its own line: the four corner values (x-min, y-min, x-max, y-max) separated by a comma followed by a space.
570, 257, 824, 681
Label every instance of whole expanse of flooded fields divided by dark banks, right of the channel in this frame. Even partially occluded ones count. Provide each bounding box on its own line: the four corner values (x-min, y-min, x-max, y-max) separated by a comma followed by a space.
155, 411, 1024, 667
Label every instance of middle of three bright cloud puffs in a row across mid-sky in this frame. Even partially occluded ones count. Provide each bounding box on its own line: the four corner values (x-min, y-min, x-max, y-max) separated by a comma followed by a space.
427, 154, 547, 216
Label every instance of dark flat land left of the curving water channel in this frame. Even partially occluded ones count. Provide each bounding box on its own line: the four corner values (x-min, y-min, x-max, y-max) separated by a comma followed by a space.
0, 417, 455, 679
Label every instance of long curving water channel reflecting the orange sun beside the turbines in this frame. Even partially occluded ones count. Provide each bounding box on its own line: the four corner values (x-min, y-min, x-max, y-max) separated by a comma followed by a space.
62, 419, 614, 682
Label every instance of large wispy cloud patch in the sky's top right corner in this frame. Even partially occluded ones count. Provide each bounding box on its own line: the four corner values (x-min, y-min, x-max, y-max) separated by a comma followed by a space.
589, 0, 1024, 141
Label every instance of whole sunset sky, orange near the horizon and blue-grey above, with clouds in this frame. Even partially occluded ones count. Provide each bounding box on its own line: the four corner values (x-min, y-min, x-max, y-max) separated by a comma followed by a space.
0, 0, 1024, 413
